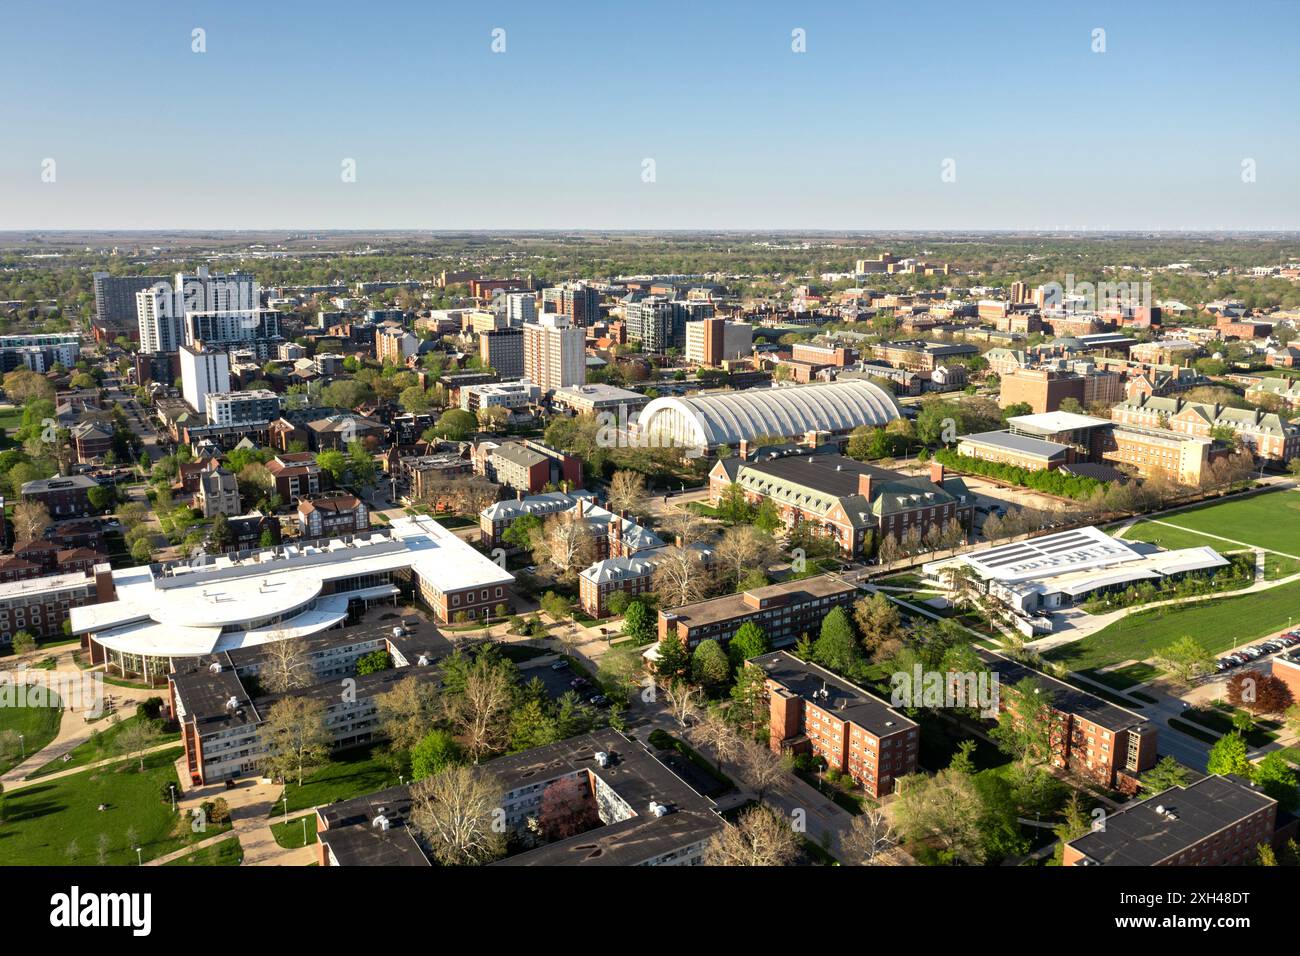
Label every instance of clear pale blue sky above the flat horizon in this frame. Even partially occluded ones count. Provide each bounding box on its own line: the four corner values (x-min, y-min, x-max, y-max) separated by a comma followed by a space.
0, 0, 1300, 229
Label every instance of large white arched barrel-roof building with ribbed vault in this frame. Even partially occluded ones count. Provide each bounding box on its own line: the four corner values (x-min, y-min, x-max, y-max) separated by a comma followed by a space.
637, 378, 901, 449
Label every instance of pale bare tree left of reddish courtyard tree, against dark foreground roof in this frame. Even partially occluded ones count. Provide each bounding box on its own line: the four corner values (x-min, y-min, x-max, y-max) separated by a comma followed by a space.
411, 766, 506, 866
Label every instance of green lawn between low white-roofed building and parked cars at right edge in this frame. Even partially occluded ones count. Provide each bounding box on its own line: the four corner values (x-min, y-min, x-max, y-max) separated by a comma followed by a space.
1045, 581, 1300, 670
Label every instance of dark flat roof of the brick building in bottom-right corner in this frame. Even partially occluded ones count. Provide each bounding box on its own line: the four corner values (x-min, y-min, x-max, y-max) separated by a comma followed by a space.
1070, 775, 1277, 866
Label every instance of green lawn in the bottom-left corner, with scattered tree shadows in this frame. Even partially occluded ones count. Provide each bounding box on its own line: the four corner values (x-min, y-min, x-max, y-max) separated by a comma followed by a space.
0, 747, 229, 866
